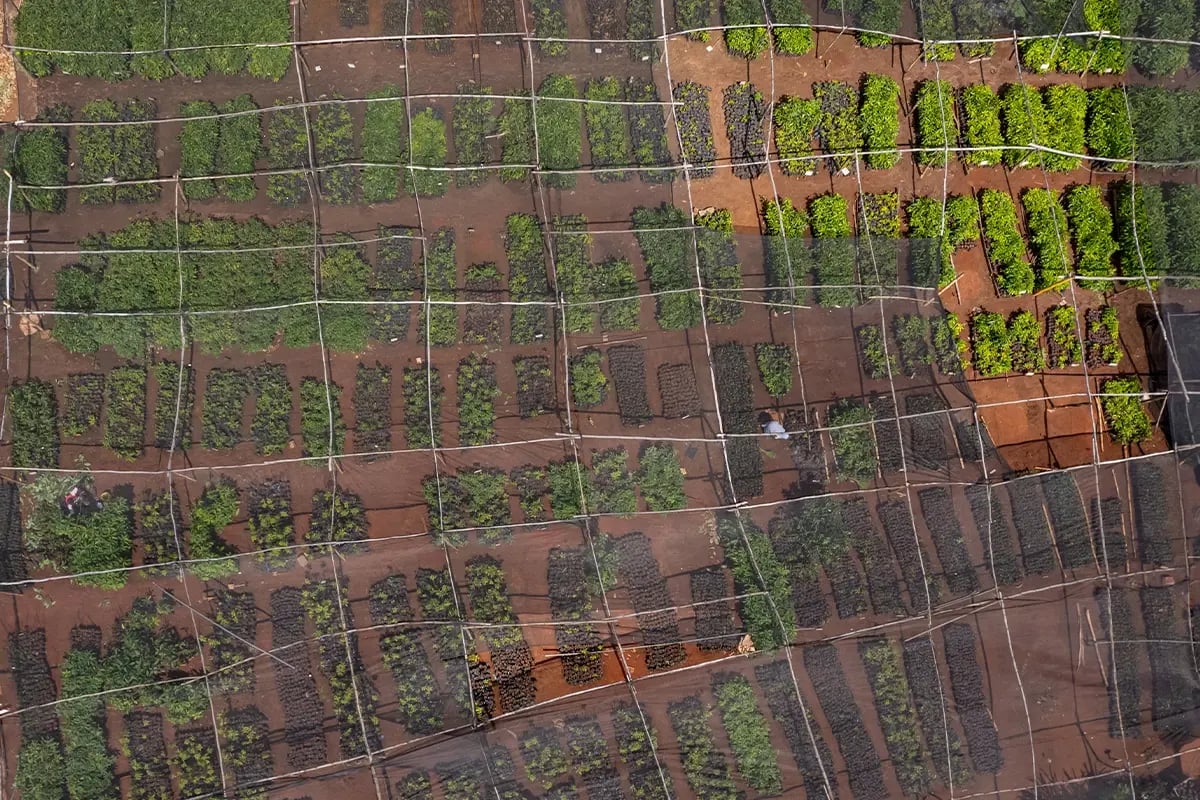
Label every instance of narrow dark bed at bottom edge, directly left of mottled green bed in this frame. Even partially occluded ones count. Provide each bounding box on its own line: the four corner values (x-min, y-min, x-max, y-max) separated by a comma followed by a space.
804, 644, 887, 800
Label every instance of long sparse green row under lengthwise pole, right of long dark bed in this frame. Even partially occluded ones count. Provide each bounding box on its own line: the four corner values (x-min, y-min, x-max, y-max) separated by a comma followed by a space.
300, 577, 383, 758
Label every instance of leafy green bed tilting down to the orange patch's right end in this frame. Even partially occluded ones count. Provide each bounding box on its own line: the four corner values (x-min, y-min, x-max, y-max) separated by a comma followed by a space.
716, 512, 796, 651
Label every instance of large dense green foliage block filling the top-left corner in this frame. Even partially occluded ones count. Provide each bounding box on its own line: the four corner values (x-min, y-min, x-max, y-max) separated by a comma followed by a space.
17, 0, 292, 80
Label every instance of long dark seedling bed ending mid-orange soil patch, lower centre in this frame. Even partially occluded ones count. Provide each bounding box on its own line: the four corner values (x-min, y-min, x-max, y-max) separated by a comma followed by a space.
617, 534, 688, 670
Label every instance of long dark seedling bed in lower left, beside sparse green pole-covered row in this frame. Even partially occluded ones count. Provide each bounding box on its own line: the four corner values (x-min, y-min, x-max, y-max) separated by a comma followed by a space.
271, 587, 326, 769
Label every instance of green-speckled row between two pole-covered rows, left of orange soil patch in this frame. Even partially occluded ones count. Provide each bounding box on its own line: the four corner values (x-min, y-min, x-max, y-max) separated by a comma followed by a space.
368, 573, 445, 736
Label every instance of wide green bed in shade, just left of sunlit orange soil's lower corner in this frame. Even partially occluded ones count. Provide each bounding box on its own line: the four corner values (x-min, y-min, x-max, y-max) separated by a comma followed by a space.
632, 203, 700, 330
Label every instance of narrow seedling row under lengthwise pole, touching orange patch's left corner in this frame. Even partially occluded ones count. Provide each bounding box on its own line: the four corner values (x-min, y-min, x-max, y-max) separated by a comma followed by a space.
416, 569, 496, 722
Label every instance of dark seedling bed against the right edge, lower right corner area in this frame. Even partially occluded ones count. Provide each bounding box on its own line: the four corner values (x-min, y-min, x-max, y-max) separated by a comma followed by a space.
1134, 587, 1198, 736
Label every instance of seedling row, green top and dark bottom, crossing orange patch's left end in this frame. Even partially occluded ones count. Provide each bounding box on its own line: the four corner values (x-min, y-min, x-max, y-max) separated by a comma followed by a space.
467, 555, 538, 711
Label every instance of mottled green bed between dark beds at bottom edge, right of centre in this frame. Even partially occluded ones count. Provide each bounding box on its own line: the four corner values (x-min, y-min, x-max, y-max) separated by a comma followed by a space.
858, 637, 934, 796
